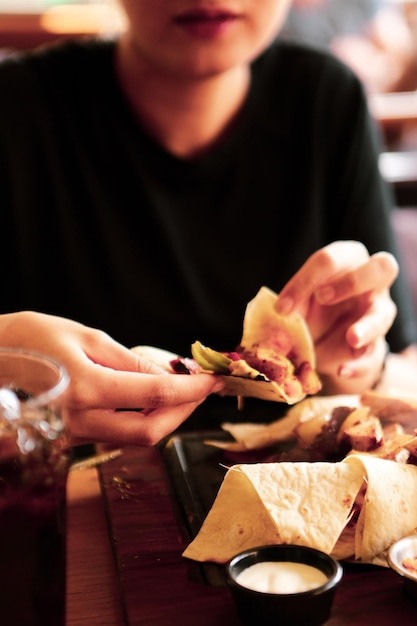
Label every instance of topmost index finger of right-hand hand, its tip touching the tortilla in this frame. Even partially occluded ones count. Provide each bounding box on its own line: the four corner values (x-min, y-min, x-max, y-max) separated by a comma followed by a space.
276, 241, 369, 315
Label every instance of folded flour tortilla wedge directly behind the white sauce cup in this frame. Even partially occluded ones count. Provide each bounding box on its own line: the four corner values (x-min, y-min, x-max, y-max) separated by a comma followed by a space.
183, 463, 363, 563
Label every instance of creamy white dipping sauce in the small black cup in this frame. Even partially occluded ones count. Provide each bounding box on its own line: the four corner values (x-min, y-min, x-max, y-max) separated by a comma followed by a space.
236, 561, 328, 593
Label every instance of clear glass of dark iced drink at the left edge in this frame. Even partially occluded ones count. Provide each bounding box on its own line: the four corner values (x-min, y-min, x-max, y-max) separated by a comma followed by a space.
0, 348, 70, 626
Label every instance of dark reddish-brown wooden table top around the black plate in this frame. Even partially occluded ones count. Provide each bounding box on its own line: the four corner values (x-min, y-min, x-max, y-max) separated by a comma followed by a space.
67, 448, 417, 626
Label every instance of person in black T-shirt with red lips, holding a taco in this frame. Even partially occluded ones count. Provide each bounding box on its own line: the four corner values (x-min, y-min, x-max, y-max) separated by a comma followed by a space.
0, 0, 416, 444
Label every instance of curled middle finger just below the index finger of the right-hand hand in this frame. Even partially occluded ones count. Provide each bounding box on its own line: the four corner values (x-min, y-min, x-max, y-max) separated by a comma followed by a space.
315, 252, 399, 304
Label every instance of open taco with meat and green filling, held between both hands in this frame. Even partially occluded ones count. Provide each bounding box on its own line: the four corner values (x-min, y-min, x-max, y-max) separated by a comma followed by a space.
191, 287, 321, 404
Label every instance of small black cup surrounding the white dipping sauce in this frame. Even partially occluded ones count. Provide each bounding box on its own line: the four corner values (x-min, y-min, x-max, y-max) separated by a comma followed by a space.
226, 544, 343, 626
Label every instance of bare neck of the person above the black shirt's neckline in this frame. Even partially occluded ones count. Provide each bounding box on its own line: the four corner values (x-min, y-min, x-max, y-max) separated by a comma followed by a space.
117, 41, 250, 158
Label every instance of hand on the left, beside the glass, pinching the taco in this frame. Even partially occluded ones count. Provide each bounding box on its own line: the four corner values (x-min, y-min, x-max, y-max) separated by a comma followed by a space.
0, 312, 222, 445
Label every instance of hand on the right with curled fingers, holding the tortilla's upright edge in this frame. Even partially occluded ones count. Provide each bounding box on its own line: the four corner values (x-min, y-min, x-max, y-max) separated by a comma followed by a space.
277, 241, 398, 393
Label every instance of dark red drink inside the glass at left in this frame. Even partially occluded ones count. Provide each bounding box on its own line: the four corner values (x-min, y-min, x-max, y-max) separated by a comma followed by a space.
0, 426, 70, 626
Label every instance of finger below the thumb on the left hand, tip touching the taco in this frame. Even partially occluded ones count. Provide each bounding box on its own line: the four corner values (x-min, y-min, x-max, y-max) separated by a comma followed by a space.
69, 363, 223, 410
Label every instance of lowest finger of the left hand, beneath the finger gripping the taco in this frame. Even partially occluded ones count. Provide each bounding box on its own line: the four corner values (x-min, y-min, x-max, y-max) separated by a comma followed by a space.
64, 402, 204, 446
